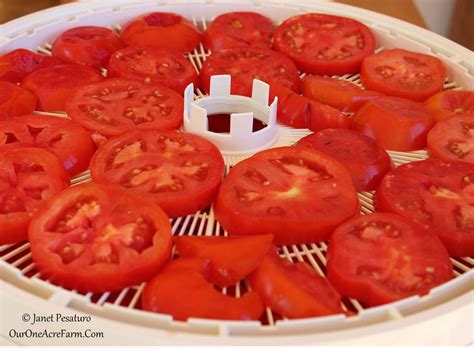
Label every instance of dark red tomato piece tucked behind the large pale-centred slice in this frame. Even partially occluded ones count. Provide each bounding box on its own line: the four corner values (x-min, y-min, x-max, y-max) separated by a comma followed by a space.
296, 129, 391, 191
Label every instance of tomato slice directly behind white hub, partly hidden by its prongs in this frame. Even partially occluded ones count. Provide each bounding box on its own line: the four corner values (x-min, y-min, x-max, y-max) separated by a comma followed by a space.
199, 47, 300, 96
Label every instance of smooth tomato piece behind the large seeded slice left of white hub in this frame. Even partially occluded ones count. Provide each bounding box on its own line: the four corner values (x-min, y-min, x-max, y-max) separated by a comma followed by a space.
21, 64, 104, 111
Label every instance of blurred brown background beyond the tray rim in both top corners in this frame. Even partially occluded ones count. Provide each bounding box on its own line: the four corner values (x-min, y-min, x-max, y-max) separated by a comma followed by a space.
0, 0, 474, 50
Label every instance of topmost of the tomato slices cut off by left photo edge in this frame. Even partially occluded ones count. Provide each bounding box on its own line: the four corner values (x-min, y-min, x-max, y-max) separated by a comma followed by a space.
0, 48, 64, 83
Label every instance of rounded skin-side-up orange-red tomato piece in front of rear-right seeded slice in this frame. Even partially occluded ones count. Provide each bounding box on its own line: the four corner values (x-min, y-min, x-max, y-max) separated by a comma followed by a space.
352, 97, 433, 151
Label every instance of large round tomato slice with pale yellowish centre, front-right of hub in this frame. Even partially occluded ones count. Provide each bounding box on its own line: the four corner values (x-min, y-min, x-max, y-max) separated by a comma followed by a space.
214, 146, 359, 244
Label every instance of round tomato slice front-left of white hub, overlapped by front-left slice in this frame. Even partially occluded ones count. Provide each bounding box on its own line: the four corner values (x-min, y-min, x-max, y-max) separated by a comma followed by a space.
91, 130, 224, 217
